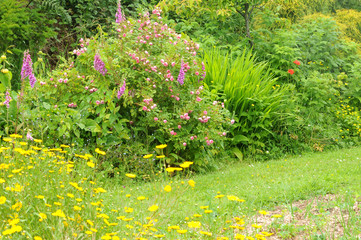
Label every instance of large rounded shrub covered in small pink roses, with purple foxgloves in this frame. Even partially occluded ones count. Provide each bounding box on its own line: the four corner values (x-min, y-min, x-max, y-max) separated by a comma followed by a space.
21, 6, 231, 173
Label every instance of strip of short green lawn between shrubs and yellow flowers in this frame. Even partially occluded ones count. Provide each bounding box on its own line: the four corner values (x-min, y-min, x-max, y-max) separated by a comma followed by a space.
104, 147, 361, 227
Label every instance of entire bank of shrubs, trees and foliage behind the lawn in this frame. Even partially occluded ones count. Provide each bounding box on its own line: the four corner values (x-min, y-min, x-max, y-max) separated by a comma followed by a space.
0, 0, 361, 166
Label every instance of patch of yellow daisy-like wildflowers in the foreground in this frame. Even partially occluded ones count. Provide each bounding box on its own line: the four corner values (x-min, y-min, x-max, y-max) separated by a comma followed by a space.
0, 134, 273, 240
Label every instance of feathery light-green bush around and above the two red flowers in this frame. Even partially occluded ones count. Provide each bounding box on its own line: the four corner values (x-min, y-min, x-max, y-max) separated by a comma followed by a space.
256, 15, 359, 84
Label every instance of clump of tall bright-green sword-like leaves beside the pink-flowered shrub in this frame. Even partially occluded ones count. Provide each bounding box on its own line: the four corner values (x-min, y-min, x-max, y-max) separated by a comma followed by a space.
204, 48, 290, 154
